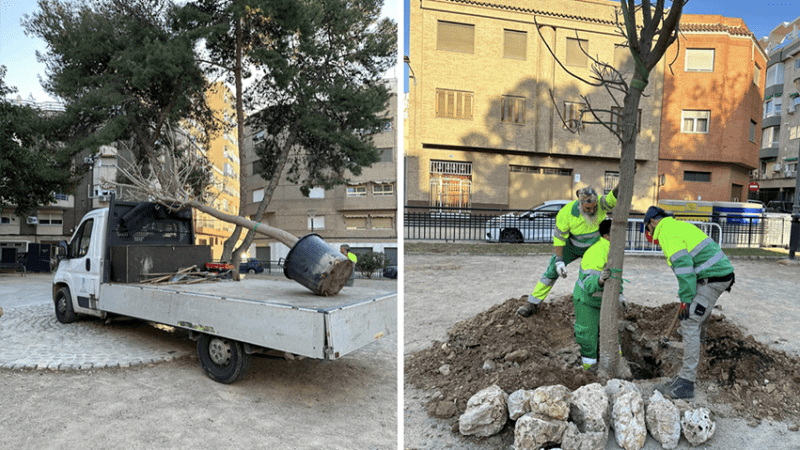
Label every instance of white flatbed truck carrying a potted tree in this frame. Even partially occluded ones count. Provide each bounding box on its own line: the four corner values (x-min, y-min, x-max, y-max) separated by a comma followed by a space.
53, 201, 397, 383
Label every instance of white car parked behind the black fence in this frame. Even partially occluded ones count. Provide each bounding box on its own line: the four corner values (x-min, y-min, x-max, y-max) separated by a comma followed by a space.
486, 200, 570, 242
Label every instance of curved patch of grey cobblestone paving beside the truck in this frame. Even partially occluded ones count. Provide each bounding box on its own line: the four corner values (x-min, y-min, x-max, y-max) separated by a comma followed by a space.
0, 302, 195, 370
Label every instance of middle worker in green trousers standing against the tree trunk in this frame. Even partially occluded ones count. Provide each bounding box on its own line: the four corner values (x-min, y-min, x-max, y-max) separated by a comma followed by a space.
572, 219, 628, 373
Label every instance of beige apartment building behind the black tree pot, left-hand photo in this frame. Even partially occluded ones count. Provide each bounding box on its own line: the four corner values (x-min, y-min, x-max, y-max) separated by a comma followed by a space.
242, 79, 398, 264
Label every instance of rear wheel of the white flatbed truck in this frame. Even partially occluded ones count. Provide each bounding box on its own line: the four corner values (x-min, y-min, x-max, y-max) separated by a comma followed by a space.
197, 334, 253, 384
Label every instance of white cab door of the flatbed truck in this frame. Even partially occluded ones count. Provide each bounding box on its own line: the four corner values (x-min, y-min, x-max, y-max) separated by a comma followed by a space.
65, 217, 102, 312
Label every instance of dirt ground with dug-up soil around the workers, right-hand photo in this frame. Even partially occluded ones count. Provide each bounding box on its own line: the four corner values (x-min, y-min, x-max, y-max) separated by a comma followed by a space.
404, 255, 800, 449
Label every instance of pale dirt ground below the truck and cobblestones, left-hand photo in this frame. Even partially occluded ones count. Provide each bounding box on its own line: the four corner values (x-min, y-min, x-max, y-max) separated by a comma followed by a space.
0, 276, 399, 450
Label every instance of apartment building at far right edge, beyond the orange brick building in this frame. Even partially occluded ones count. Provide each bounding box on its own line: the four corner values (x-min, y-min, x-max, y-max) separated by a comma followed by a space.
752, 17, 800, 203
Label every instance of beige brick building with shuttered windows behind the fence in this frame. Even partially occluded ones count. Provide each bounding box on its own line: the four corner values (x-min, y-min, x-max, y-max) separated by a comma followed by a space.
405, 0, 664, 211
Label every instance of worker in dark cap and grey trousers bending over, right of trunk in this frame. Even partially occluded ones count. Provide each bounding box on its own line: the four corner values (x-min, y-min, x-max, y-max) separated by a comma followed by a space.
644, 206, 735, 398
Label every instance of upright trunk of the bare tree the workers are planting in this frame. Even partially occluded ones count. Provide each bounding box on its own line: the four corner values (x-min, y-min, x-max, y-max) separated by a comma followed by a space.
599, 80, 641, 377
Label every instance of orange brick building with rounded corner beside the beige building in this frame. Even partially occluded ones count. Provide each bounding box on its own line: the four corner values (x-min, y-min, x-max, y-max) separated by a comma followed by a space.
659, 14, 770, 202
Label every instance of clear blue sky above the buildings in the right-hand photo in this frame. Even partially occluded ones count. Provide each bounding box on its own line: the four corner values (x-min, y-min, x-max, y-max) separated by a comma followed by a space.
403, 0, 800, 92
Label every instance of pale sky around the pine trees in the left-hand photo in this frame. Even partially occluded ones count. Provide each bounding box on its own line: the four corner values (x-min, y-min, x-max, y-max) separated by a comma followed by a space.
0, 0, 401, 102
